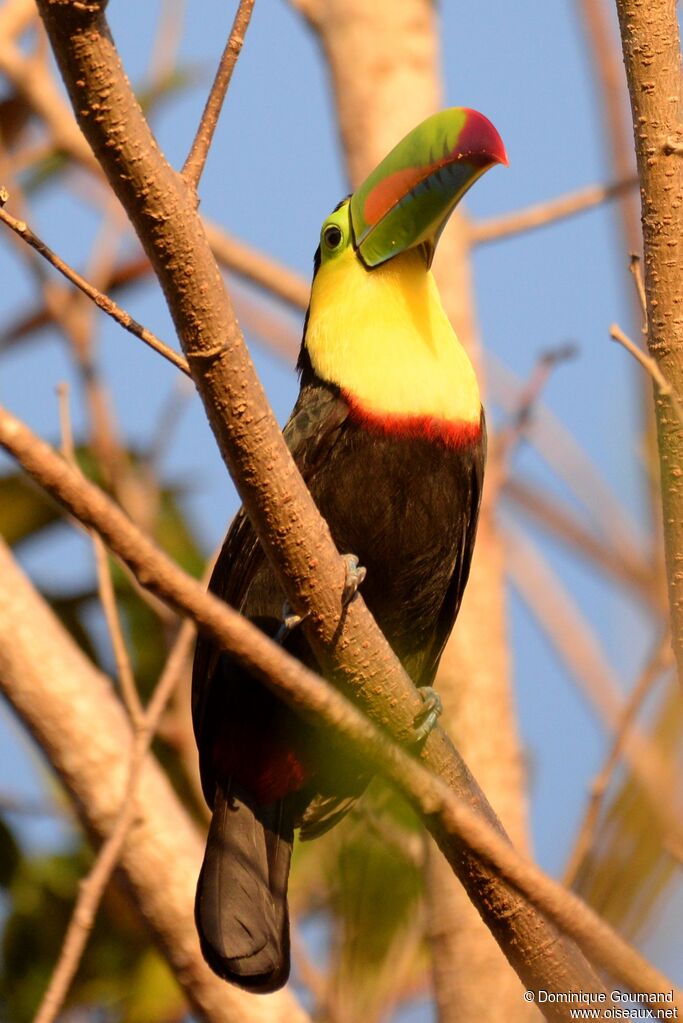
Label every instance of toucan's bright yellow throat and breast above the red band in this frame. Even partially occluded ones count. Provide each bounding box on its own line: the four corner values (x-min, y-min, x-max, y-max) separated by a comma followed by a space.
306, 246, 481, 424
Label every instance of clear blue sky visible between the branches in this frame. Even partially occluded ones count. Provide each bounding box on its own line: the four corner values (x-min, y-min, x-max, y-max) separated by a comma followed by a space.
0, 0, 683, 1010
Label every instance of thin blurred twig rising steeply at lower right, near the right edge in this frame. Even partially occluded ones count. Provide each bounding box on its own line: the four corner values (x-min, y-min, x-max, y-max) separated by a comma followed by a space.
562, 630, 673, 888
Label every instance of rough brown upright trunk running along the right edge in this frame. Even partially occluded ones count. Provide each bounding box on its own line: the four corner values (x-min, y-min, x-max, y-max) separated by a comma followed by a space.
617, 0, 683, 679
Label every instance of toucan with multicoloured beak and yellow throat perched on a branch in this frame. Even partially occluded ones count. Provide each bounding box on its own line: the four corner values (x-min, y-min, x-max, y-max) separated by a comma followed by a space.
192, 107, 507, 992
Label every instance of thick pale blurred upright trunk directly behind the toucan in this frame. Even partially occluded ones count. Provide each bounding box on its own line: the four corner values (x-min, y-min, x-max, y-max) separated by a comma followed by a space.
298, 0, 527, 1023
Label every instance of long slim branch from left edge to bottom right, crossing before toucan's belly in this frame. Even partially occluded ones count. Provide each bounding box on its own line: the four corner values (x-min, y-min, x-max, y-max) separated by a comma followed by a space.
0, 412, 683, 1020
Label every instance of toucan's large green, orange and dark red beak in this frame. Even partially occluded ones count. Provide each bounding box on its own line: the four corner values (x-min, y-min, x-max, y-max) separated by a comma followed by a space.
351, 106, 507, 267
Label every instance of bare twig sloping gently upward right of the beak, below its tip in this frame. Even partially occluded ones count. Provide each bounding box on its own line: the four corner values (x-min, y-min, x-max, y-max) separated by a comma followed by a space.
469, 176, 638, 246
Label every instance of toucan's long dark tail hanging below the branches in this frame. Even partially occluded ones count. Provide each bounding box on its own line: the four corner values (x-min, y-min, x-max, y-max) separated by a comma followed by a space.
194, 783, 293, 992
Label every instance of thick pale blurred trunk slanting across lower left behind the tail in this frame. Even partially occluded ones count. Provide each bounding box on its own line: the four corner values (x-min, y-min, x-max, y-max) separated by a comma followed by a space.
0, 540, 308, 1023
